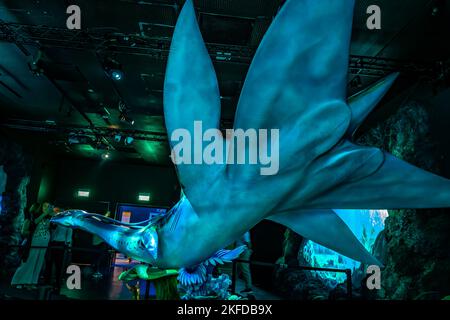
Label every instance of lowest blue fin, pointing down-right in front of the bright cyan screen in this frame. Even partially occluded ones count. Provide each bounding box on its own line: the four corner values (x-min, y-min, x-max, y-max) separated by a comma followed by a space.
267, 209, 382, 266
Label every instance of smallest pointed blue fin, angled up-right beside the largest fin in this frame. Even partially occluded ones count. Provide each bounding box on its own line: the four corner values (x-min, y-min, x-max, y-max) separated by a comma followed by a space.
347, 73, 399, 136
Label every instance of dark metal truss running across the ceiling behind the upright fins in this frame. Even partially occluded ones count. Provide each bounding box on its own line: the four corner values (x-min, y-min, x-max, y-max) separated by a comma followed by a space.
0, 21, 436, 77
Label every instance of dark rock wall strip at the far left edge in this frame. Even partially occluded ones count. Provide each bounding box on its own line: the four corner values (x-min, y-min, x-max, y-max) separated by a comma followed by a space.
0, 136, 30, 277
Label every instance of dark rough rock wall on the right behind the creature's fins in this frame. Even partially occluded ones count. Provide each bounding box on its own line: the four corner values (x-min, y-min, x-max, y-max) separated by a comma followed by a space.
359, 102, 450, 300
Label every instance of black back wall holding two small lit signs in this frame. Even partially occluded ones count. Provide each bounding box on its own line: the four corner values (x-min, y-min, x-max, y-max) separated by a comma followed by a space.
39, 159, 180, 210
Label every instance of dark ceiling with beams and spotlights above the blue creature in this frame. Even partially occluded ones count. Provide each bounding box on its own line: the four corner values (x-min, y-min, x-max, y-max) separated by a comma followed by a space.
0, 0, 450, 165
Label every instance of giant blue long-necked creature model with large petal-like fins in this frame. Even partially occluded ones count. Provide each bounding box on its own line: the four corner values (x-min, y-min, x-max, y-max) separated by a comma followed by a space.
53, 0, 450, 278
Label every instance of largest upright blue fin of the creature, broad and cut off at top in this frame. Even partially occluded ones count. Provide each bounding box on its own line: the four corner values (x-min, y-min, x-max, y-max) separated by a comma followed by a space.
227, 0, 354, 179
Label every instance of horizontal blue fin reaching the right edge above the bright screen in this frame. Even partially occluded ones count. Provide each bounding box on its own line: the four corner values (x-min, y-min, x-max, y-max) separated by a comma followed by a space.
302, 153, 450, 209
